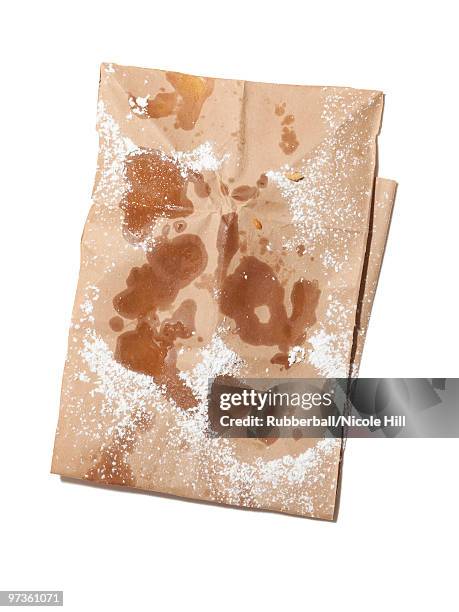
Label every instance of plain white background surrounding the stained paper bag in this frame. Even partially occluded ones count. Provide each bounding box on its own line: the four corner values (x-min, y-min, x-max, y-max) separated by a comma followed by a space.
0, 0, 459, 612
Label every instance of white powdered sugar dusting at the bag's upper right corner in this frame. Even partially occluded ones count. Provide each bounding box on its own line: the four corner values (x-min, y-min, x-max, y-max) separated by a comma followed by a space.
267, 88, 377, 272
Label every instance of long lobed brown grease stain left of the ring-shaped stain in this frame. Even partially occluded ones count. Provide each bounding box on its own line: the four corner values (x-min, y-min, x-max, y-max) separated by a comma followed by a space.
113, 234, 207, 409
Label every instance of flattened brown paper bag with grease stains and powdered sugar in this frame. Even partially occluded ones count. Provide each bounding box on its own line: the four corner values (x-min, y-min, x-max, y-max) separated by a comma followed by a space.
52, 64, 395, 519
